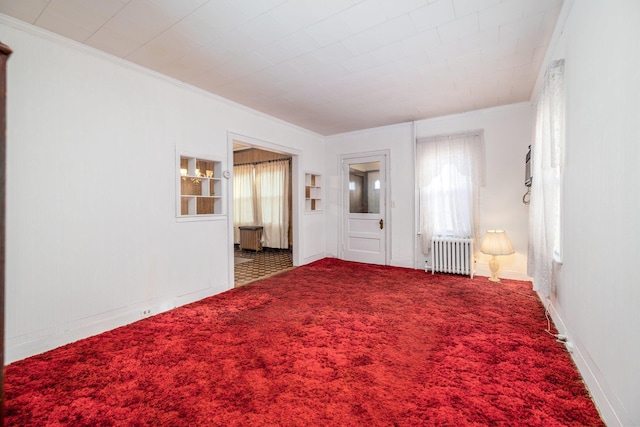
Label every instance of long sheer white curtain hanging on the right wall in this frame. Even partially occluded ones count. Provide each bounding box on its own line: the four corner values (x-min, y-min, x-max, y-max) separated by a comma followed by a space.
527, 60, 564, 296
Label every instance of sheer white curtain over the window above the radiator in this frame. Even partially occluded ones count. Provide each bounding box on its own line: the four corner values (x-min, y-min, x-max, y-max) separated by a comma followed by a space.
416, 130, 484, 256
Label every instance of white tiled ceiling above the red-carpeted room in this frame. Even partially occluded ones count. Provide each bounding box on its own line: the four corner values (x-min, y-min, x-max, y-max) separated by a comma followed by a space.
0, 0, 562, 135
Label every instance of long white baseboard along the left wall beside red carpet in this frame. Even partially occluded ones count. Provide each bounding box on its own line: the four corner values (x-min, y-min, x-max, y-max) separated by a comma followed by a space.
4, 288, 217, 364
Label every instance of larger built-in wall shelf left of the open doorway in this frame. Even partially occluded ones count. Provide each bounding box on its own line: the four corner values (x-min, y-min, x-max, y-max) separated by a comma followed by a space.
176, 155, 223, 218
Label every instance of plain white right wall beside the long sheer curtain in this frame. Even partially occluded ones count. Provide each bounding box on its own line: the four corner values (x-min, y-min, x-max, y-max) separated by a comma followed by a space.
534, 0, 640, 426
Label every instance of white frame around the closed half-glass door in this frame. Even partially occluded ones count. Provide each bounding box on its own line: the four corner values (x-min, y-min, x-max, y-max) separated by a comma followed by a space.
338, 150, 391, 265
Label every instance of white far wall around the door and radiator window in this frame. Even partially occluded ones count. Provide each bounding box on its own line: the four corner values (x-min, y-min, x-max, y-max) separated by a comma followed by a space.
326, 103, 533, 280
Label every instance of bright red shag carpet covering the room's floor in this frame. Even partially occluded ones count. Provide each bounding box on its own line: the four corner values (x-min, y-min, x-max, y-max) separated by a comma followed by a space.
5, 259, 603, 427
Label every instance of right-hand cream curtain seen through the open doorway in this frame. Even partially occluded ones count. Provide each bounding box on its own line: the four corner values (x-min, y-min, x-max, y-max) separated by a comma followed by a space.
256, 160, 289, 249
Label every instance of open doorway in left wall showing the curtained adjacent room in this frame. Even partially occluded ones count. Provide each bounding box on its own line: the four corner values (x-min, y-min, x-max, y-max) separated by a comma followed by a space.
230, 137, 297, 287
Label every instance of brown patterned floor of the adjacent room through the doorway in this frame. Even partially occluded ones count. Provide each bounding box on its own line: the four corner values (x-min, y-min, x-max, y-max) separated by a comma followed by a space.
234, 245, 293, 287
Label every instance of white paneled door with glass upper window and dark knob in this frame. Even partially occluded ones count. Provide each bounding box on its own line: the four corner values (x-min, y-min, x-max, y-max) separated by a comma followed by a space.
342, 155, 387, 265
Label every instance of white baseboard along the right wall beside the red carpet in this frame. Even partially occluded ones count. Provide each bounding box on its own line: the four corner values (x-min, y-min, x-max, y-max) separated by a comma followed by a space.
538, 295, 630, 427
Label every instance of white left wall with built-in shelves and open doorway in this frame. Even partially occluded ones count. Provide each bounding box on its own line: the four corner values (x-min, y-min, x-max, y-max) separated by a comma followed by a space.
0, 16, 324, 362
